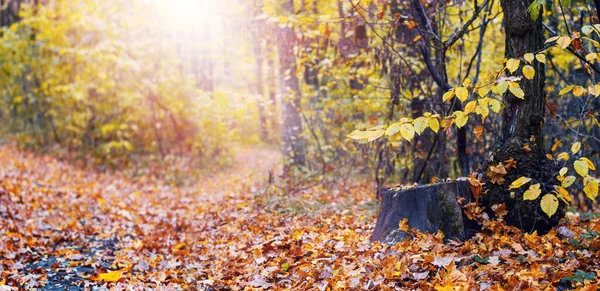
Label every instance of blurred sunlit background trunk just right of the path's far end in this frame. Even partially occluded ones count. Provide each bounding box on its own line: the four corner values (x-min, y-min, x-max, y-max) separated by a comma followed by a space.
278, 0, 305, 173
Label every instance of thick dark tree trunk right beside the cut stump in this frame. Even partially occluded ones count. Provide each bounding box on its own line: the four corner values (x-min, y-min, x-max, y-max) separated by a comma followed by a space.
483, 0, 565, 232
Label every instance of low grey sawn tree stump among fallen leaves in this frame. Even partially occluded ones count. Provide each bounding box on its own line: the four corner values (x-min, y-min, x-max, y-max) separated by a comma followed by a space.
371, 180, 480, 244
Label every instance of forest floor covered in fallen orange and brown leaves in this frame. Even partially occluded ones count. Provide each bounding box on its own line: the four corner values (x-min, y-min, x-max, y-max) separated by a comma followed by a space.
0, 146, 600, 291
